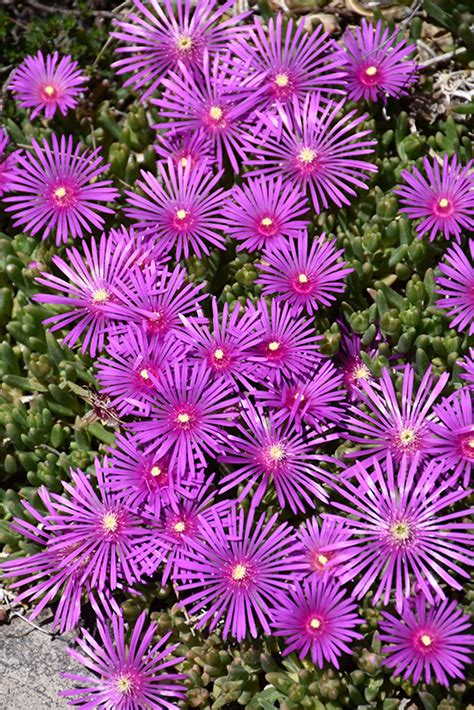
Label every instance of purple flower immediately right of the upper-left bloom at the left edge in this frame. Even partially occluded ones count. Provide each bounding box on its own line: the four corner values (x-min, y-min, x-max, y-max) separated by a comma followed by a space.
125, 159, 228, 260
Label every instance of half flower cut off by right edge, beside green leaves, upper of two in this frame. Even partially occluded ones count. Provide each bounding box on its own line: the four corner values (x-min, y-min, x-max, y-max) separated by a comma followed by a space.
436, 241, 474, 335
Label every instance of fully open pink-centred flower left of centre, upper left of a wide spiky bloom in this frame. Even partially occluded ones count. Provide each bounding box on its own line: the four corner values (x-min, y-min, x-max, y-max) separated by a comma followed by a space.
134, 361, 238, 478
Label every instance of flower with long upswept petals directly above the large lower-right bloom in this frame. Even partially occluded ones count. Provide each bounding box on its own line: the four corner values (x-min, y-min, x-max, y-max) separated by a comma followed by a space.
345, 365, 449, 459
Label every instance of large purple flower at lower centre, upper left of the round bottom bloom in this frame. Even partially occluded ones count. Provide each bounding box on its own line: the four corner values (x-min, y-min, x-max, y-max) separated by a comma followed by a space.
177, 507, 302, 641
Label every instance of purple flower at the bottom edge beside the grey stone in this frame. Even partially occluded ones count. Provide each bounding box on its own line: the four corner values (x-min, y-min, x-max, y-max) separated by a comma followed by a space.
59, 611, 186, 710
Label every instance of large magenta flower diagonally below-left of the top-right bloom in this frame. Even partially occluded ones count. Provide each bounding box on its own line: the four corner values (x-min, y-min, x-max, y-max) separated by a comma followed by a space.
246, 94, 377, 214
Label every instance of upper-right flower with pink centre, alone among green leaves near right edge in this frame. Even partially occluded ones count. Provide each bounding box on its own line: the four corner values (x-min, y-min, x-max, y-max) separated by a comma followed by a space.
394, 153, 474, 242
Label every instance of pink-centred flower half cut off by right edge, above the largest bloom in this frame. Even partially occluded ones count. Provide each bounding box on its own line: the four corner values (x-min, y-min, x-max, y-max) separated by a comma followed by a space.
429, 387, 474, 487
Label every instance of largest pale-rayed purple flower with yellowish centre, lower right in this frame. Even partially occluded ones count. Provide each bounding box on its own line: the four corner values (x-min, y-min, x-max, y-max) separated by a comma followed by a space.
327, 457, 474, 611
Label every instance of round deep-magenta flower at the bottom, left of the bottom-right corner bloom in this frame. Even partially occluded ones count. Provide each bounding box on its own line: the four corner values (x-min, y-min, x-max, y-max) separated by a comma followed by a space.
272, 578, 363, 668
